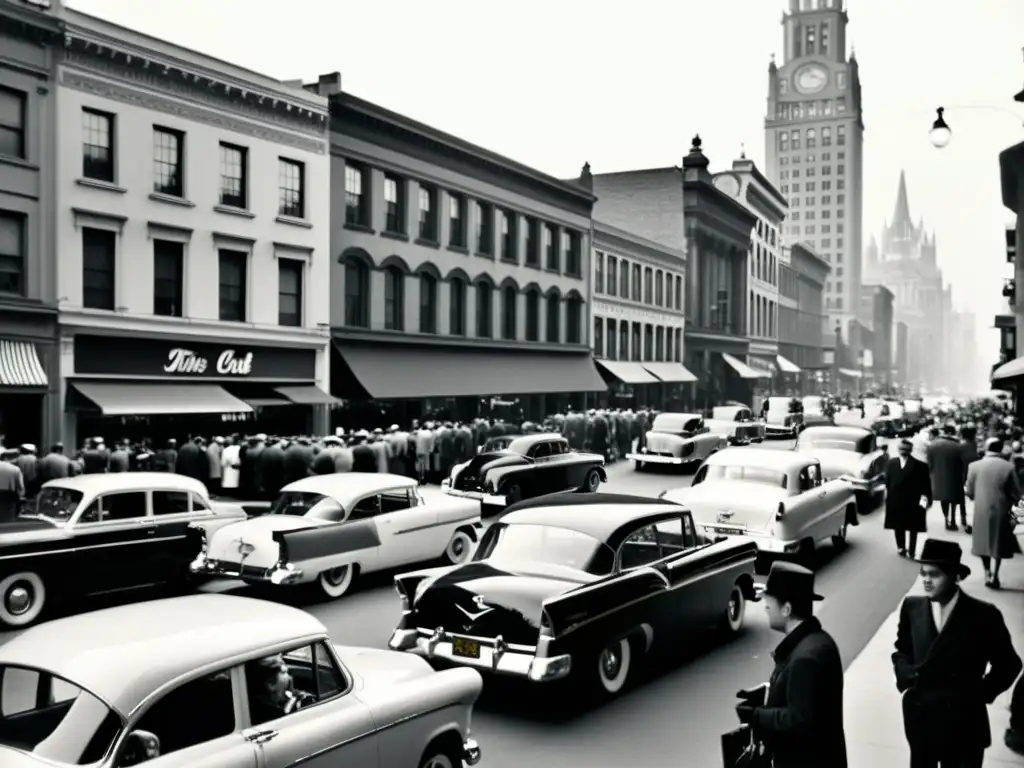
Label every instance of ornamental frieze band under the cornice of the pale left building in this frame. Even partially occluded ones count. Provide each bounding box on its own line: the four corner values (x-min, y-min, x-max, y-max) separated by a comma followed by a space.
60, 69, 329, 155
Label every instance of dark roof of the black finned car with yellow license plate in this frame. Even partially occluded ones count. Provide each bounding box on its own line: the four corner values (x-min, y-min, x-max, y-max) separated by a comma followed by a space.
499, 494, 685, 547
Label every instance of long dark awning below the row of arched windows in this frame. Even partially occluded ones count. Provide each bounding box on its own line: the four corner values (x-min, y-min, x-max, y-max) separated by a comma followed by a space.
332, 341, 608, 400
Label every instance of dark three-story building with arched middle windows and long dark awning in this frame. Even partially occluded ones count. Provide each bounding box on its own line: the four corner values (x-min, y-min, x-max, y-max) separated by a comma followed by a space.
307, 75, 606, 426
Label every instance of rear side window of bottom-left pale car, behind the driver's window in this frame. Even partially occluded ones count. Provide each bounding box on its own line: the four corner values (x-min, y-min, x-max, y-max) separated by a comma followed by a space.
123, 670, 236, 766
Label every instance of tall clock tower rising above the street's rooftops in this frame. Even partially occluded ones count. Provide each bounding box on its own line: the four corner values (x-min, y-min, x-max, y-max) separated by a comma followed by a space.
765, 0, 864, 346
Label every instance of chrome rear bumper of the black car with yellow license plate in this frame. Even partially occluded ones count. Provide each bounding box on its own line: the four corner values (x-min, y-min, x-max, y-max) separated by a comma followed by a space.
388, 629, 572, 683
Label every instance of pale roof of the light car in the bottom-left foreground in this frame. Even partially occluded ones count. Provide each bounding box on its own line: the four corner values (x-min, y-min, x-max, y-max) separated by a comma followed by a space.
0, 595, 327, 718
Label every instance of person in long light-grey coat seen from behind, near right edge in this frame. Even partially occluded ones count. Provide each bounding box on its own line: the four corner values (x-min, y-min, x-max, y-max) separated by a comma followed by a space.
965, 438, 1021, 589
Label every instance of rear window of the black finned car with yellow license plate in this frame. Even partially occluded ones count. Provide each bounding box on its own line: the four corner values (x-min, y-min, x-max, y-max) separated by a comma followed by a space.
475, 522, 615, 575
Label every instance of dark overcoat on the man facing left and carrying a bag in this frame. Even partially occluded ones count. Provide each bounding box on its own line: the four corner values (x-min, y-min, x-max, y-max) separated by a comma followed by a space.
751, 618, 847, 768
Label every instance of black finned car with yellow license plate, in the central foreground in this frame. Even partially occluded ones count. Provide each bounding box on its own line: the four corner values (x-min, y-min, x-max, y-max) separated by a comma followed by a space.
390, 494, 757, 696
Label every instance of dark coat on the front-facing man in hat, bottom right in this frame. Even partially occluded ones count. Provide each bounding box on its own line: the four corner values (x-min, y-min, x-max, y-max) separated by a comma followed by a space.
893, 592, 1021, 756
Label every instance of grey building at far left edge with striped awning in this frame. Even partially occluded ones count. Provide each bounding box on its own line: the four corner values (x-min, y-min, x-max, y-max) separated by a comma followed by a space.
0, 0, 63, 445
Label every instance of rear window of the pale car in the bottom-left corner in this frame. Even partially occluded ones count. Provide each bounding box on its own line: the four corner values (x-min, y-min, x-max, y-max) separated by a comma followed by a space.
0, 665, 122, 765
